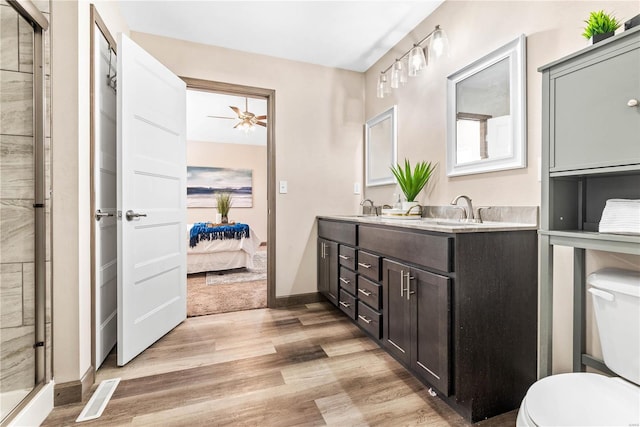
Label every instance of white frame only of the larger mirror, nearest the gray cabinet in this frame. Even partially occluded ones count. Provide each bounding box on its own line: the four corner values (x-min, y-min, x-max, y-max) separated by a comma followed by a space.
447, 34, 527, 176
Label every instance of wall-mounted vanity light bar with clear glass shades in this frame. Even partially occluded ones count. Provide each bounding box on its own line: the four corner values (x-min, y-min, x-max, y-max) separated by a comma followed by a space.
376, 25, 449, 98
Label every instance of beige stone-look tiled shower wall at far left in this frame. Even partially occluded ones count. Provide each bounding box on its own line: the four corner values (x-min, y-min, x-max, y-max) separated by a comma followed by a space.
0, 0, 51, 402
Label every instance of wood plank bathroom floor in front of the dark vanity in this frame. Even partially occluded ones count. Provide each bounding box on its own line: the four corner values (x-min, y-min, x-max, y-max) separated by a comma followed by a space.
43, 303, 516, 427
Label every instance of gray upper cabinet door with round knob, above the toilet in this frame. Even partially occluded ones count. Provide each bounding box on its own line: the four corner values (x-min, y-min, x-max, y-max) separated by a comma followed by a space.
550, 45, 640, 172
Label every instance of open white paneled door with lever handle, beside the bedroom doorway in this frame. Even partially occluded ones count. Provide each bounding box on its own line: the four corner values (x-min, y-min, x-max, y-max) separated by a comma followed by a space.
117, 34, 187, 366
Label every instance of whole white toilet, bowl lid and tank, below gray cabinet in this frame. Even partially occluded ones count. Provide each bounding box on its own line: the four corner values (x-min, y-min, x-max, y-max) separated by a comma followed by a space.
516, 269, 640, 427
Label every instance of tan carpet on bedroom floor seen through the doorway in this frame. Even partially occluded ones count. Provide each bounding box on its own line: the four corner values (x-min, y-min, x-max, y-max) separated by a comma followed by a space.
187, 251, 267, 317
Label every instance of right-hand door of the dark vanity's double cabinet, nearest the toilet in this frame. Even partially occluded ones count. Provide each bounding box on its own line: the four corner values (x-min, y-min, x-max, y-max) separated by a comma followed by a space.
409, 269, 451, 396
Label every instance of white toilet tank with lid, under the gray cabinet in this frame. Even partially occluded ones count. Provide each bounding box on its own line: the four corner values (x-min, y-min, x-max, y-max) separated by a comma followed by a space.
587, 268, 640, 385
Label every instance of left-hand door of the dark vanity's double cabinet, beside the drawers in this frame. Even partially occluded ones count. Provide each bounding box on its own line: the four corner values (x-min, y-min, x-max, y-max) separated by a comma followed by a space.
382, 259, 411, 365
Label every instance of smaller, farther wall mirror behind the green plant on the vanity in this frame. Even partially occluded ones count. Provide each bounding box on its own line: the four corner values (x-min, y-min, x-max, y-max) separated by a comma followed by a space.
364, 105, 397, 187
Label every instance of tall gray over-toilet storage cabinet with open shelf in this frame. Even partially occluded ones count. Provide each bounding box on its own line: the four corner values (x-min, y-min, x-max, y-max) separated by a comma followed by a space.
539, 28, 640, 377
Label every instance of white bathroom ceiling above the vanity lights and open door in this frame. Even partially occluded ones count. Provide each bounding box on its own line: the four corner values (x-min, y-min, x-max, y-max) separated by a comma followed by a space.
119, 0, 444, 72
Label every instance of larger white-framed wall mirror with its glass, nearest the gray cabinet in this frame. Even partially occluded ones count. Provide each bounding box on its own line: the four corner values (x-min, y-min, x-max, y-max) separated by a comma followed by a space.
447, 34, 527, 176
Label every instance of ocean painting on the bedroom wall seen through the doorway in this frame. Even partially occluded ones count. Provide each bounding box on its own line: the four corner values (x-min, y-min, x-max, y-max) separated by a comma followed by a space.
187, 166, 253, 208
